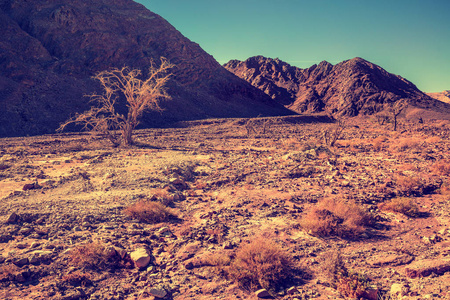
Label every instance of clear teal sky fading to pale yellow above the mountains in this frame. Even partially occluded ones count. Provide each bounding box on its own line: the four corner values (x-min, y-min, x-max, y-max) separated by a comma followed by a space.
136, 0, 450, 92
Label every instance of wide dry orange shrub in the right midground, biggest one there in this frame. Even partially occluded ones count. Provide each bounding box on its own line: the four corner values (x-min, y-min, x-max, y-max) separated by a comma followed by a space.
300, 199, 374, 239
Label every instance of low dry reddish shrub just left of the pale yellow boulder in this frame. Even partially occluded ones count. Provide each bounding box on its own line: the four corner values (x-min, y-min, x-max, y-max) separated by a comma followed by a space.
69, 242, 130, 271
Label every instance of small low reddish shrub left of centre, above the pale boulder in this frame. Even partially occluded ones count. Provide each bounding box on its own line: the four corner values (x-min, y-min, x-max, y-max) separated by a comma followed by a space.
123, 200, 176, 224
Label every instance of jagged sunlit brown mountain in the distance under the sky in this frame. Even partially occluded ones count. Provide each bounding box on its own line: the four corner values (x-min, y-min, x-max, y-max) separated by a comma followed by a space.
224, 56, 450, 116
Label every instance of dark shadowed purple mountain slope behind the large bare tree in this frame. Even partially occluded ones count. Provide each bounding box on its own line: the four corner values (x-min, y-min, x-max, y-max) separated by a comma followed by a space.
0, 0, 292, 136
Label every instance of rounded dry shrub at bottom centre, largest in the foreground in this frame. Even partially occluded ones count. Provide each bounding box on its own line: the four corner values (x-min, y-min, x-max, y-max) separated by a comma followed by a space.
226, 237, 296, 291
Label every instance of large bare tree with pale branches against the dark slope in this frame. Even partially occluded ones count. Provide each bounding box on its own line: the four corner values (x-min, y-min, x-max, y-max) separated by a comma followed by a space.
58, 58, 173, 146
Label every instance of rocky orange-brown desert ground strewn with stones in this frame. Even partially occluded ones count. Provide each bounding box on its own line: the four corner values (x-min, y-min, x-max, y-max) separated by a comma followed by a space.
0, 116, 450, 300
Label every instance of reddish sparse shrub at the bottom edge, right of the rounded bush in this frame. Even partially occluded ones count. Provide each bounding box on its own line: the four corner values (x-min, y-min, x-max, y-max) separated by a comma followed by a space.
322, 251, 369, 299
